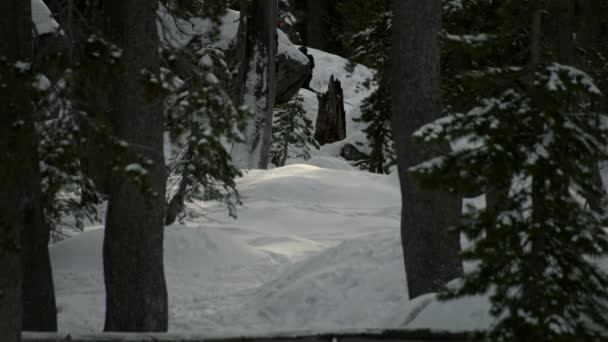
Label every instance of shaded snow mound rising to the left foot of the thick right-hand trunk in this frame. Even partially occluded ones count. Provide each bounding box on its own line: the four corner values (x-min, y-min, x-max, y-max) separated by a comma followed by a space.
250, 232, 407, 331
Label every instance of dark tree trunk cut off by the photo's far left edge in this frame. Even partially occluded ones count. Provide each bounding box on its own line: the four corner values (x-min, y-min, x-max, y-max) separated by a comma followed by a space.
0, 0, 40, 342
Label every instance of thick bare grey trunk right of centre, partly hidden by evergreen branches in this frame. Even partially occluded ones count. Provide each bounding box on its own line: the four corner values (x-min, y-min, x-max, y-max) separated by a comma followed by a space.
392, 0, 463, 298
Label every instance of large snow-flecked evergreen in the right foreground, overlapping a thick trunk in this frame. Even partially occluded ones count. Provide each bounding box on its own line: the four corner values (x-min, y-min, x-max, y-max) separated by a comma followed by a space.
410, 1, 608, 341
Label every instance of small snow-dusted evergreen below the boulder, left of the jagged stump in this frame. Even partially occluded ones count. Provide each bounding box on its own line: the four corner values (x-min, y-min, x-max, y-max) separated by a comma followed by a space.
270, 93, 319, 166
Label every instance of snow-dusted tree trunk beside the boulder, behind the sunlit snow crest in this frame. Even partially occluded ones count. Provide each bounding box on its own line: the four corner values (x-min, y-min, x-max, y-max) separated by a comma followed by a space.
231, 0, 278, 169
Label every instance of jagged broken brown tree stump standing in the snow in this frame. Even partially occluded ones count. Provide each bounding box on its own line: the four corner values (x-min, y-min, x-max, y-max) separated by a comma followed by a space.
315, 75, 346, 145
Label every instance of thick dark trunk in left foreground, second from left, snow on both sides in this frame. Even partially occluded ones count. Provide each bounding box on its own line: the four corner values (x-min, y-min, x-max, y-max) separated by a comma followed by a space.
102, 0, 168, 332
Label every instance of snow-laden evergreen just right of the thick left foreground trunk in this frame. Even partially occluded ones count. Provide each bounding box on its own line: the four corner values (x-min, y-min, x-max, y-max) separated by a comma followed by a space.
164, 47, 247, 225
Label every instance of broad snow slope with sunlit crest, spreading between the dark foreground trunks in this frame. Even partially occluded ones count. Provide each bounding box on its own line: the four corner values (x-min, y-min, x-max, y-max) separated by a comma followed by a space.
51, 165, 406, 336
